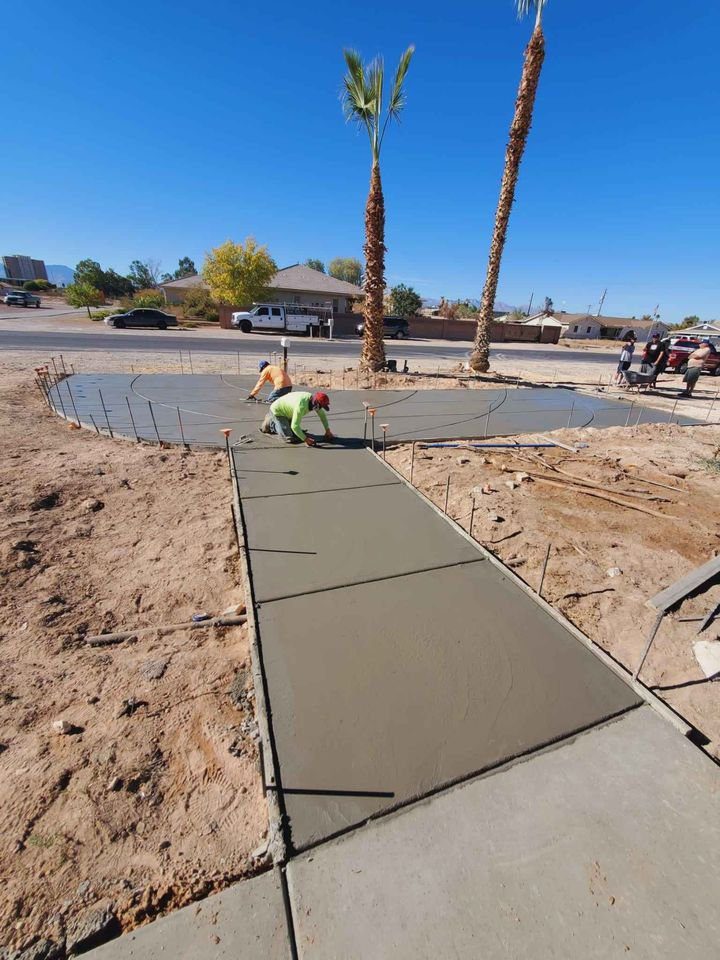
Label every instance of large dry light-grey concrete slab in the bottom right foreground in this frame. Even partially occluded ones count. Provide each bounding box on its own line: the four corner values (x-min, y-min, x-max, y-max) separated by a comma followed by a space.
288, 707, 720, 960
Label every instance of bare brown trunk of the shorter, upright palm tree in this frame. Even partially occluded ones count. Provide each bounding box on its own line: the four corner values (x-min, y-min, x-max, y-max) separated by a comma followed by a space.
360, 162, 385, 372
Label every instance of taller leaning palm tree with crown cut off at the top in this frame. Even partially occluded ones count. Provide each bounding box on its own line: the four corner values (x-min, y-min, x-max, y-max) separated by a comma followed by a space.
470, 0, 547, 373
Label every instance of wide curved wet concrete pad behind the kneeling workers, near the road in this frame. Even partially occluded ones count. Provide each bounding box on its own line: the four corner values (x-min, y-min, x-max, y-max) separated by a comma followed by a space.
43, 374, 692, 446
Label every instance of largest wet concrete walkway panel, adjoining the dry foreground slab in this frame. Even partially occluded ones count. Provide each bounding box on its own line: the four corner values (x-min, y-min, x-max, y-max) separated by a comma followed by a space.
258, 564, 639, 847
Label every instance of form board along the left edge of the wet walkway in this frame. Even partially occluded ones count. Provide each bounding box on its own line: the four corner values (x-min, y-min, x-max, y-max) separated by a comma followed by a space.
230, 453, 288, 865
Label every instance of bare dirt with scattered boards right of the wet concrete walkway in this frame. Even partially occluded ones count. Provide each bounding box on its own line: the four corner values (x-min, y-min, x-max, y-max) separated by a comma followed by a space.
387, 424, 720, 757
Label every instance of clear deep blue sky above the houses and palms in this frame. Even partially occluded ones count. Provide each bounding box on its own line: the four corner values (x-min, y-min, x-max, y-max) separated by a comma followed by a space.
0, 0, 720, 322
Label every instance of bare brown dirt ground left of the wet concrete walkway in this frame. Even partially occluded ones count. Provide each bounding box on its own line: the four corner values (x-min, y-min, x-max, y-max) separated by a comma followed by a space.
0, 357, 267, 956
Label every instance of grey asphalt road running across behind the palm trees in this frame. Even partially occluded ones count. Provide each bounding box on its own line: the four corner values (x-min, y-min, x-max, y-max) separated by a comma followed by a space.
0, 329, 615, 366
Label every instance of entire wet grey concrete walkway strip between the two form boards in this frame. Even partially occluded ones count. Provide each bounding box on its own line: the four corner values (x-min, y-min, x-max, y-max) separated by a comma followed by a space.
234, 444, 639, 848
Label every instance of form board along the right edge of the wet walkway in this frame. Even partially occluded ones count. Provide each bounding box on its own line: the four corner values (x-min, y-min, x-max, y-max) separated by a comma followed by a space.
368, 447, 693, 737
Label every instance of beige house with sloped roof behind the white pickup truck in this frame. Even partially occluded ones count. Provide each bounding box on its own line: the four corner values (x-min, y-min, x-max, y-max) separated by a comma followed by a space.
160, 263, 363, 314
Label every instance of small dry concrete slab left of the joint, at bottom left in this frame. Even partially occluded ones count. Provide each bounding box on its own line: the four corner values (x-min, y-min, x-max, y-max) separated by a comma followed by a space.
84, 870, 291, 960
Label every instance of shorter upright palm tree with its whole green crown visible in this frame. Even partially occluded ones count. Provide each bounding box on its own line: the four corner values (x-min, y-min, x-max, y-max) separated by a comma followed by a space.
342, 46, 415, 371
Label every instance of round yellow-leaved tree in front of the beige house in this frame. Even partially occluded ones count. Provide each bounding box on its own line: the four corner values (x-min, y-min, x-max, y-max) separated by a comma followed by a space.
202, 237, 277, 306
